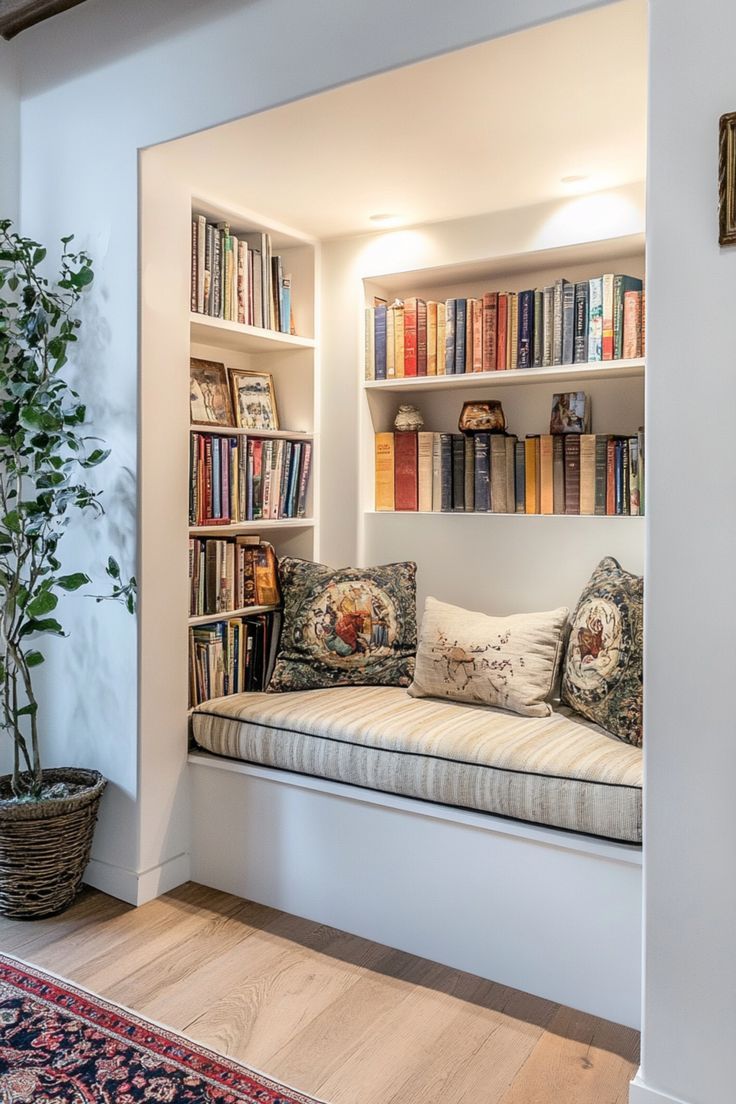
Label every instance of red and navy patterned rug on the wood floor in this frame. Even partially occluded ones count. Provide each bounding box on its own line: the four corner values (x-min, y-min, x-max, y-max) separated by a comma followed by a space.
0, 955, 324, 1104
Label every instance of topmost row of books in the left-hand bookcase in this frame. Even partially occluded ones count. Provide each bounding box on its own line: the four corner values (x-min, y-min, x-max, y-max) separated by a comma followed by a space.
191, 215, 294, 333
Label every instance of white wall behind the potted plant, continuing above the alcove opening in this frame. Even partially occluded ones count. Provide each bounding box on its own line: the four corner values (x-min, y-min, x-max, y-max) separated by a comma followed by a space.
12, 0, 609, 898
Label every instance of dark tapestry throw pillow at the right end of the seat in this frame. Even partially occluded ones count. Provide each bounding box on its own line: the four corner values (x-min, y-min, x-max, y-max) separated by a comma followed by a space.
562, 556, 643, 747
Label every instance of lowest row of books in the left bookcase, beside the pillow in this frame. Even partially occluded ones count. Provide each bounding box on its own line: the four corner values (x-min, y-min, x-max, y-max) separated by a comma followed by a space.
189, 611, 280, 705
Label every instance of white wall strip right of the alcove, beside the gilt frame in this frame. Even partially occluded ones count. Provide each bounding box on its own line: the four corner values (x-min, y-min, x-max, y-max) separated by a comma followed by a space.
632, 0, 736, 1104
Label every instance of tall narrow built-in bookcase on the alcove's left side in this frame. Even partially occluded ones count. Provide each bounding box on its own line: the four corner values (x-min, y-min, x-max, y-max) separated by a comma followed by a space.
188, 199, 318, 704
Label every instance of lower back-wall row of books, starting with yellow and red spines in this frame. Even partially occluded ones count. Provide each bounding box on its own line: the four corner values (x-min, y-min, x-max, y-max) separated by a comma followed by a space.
375, 429, 644, 516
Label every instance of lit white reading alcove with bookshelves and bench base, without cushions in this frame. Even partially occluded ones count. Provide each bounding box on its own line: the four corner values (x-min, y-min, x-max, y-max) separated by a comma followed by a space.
140, 3, 646, 1026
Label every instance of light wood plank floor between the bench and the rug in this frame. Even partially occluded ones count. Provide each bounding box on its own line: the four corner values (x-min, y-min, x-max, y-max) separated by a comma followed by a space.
0, 884, 639, 1104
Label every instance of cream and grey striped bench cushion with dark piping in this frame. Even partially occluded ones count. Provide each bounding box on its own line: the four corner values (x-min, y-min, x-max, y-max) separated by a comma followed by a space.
192, 687, 642, 843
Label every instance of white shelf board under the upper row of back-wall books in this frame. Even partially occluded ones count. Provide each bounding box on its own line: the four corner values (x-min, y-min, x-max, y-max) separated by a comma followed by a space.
363, 358, 644, 391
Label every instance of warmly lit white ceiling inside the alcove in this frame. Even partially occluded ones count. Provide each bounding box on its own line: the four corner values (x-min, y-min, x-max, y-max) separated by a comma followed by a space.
155, 0, 647, 238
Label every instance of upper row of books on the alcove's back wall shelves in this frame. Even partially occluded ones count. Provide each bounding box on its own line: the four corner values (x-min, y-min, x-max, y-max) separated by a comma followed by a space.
365, 273, 646, 380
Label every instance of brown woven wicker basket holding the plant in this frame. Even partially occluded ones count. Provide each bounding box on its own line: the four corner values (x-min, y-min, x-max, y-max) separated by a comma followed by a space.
0, 767, 106, 920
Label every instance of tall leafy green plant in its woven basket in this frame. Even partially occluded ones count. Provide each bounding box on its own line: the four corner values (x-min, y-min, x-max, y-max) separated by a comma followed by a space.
0, 221, 136, 917
